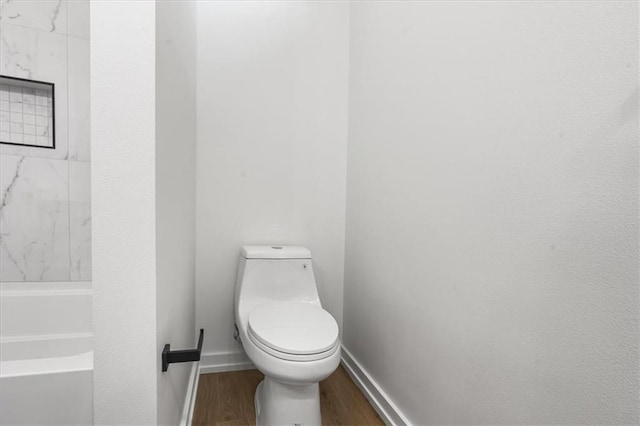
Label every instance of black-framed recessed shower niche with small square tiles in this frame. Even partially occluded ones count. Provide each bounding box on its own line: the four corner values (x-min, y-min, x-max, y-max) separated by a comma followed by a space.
0, 75, 56, 149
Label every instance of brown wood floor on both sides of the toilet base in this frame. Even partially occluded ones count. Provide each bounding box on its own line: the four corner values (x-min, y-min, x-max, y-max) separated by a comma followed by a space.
193, 366, 384, 426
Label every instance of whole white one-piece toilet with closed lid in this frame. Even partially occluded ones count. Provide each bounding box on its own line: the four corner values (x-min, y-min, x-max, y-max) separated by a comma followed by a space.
234, 246, 340, 426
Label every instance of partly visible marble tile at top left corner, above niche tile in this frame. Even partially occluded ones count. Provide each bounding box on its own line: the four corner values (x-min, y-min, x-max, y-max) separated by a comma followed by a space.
0, 0, 67, 34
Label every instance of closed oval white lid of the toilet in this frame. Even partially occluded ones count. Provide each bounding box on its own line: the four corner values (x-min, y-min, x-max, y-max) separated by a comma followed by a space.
249, 302, 338, 355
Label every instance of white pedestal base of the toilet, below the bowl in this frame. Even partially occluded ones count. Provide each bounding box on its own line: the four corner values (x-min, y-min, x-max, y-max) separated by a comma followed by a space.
254, 377, 322, 426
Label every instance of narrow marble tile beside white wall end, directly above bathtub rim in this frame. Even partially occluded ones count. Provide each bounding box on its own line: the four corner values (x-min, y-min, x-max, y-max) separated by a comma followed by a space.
69, 161, 91, 281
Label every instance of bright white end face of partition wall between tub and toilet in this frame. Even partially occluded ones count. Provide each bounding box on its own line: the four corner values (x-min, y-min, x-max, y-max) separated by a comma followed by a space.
91, 2, 159, 425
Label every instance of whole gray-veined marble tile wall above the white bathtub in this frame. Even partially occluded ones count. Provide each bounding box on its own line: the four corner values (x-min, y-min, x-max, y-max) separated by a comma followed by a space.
0, 0, 91, 282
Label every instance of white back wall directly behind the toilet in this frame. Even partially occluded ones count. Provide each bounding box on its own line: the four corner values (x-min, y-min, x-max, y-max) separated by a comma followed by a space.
196, 2, 348, 360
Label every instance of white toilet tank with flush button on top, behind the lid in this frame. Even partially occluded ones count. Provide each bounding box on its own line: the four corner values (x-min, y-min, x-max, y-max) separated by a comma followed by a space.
235, 246, 320, 307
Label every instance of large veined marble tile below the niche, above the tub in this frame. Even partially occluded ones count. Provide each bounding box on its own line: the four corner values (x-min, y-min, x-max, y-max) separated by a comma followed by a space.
0, 155, 69, 281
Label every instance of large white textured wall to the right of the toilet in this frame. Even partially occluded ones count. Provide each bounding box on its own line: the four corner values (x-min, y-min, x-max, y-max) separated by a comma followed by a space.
344, 2, 639, 424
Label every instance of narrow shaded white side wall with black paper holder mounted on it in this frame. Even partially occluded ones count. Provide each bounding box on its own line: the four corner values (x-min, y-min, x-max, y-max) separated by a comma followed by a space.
156, 1, 197, 424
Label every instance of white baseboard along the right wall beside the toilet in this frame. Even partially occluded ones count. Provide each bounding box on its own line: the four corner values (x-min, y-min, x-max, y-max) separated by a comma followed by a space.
342, 346, 411, 426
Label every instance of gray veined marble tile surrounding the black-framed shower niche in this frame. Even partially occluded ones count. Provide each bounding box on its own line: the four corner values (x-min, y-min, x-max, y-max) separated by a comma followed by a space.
0, 24, 69, 159
